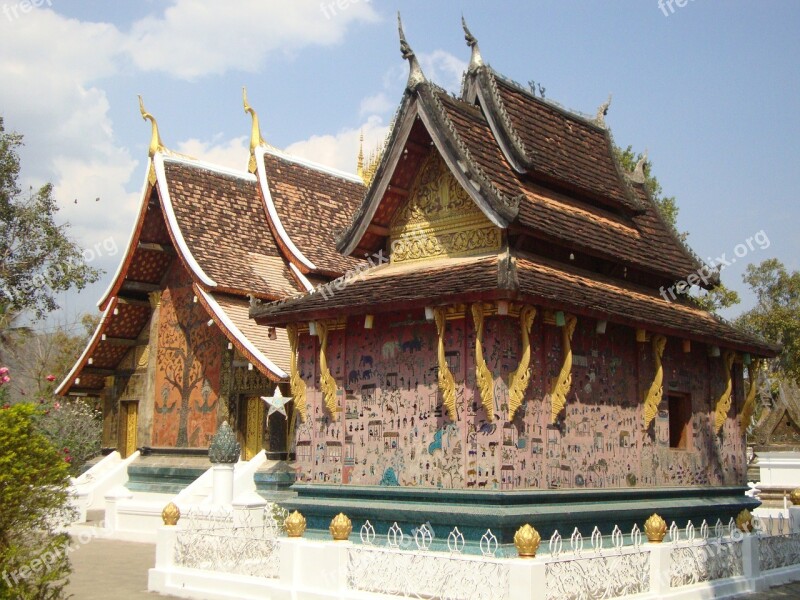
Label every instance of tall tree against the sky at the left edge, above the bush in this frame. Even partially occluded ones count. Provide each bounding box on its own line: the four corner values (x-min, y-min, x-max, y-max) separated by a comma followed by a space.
0, 117, 100, 319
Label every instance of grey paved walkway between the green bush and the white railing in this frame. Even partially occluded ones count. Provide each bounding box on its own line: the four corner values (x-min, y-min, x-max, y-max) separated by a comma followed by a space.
67, 538, 174, 600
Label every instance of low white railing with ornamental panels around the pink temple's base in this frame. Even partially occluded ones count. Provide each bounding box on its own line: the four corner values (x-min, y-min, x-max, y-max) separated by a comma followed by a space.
149, 508, 800, 600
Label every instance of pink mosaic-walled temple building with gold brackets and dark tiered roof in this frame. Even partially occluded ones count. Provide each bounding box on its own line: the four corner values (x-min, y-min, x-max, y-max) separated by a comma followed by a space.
250, 25, 778, 542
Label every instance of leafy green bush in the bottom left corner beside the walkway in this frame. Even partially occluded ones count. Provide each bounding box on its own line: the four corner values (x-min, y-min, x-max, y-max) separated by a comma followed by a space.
0, 387, 72, 600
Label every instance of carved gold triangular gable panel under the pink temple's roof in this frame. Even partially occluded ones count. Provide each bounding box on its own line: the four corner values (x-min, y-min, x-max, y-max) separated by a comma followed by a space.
389, 151, 502, 263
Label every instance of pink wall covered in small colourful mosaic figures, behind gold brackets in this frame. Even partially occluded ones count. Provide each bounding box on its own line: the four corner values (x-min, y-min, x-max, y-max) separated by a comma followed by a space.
296, 315, 745, 490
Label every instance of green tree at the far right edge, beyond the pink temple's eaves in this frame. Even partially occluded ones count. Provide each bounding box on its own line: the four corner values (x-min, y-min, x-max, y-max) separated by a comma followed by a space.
736, 258, 800, 384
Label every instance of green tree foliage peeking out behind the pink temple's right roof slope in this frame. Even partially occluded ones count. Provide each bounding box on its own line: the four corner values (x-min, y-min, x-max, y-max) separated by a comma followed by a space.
614, 146, 739, 312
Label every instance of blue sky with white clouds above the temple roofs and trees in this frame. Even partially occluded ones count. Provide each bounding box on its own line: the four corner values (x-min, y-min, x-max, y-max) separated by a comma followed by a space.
0, 0, 800, 330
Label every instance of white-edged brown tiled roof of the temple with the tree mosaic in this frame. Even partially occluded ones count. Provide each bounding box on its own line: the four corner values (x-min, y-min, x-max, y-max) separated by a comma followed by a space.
56, 102, 364, 395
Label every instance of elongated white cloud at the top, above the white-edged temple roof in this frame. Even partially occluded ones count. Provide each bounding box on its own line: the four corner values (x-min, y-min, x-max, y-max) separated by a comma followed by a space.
127, 0, 378, 80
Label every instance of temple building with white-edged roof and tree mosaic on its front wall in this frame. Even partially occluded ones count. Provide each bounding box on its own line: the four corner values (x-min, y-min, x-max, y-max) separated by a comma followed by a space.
57, 92, 365, 491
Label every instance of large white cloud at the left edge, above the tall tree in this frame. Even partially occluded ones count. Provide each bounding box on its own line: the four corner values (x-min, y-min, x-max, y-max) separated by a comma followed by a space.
0, 9, 138, 268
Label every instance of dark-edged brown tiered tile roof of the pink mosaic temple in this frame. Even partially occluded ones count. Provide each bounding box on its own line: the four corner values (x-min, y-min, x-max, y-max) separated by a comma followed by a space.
251, 17, 776, 355
